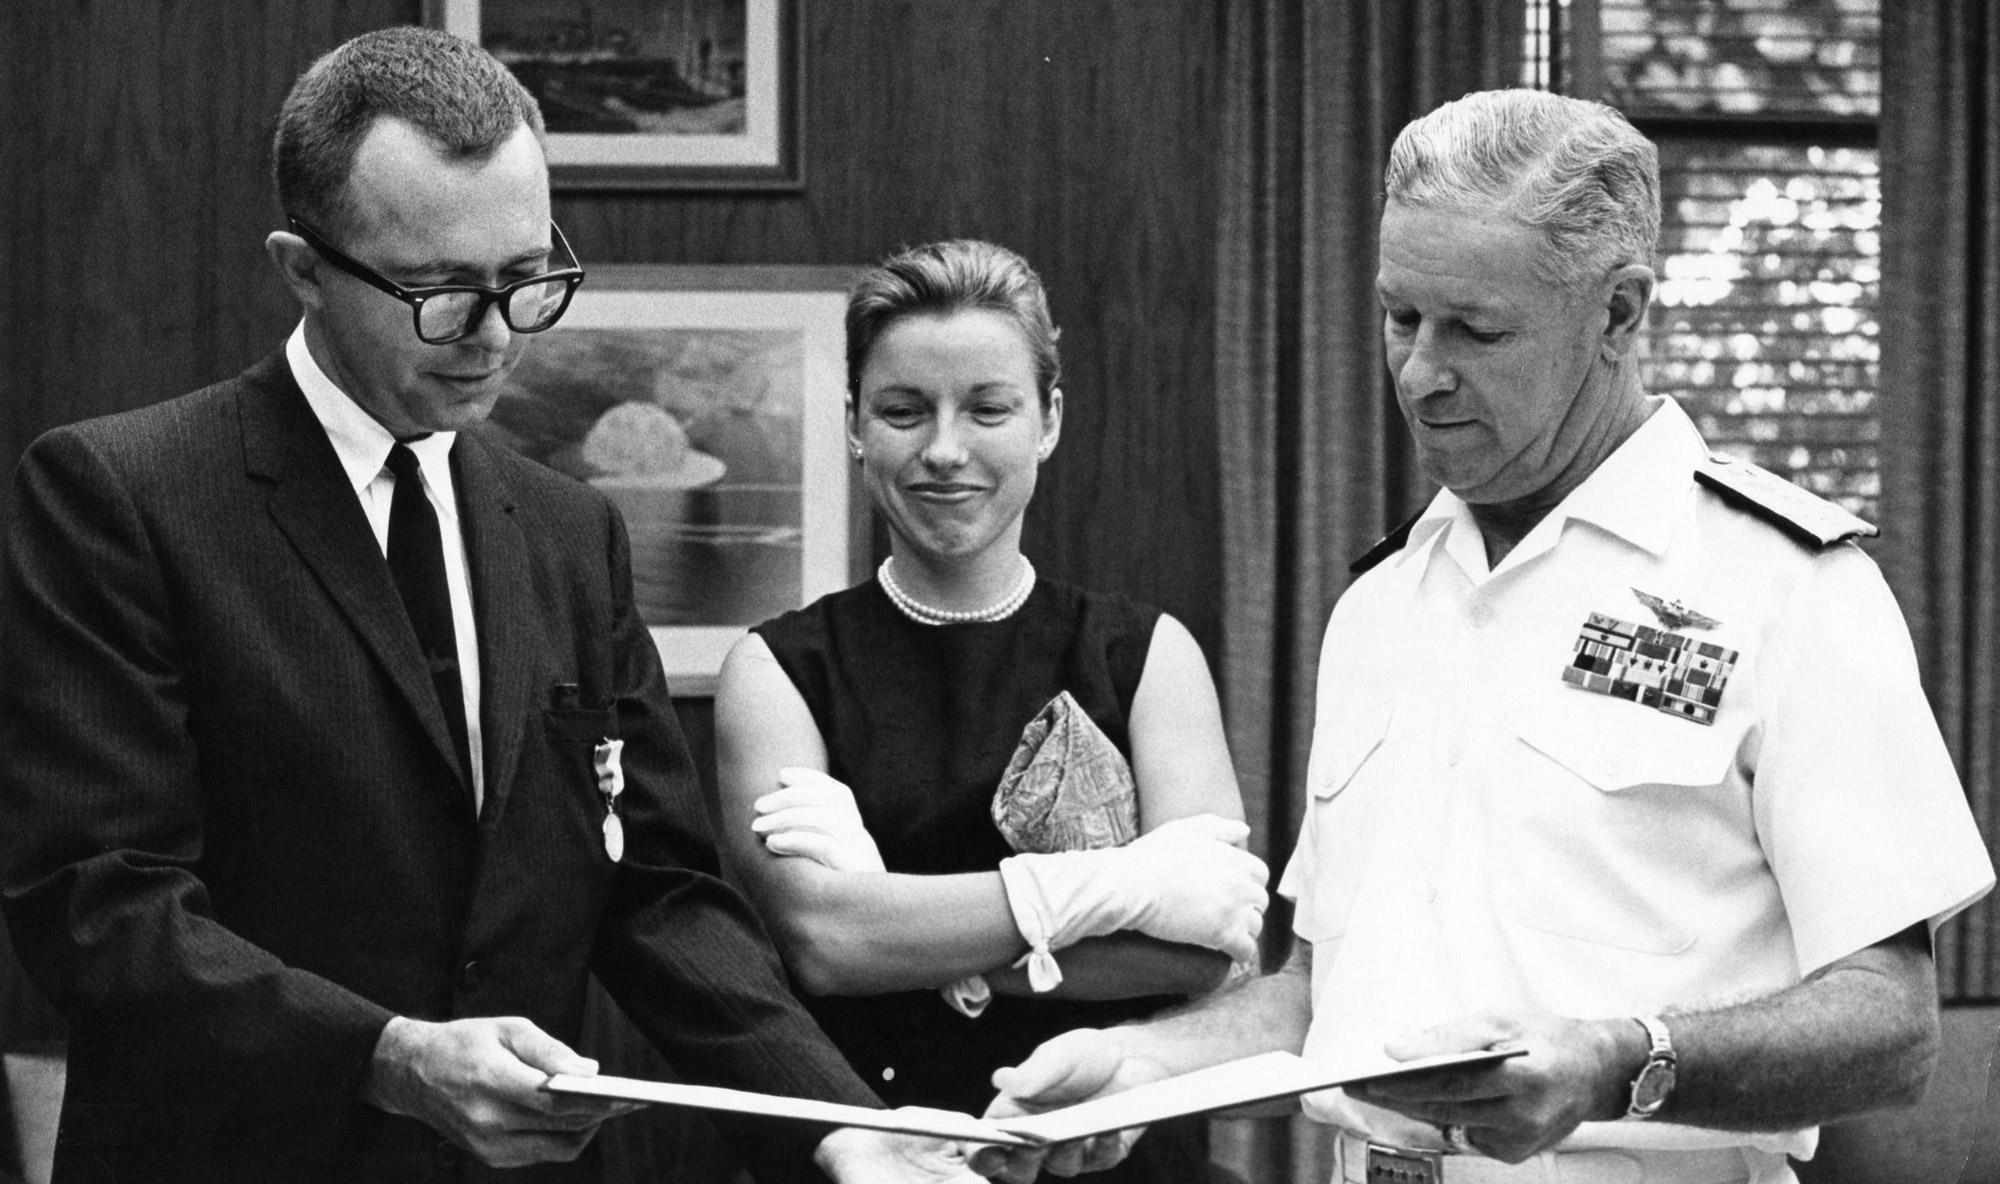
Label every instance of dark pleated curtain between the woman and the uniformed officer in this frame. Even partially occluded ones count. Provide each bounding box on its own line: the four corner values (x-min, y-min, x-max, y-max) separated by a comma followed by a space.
1216, 0, 1526, 1184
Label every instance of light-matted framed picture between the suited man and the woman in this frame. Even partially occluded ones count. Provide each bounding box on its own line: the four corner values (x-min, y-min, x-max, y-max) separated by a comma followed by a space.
482, 264, 868, 696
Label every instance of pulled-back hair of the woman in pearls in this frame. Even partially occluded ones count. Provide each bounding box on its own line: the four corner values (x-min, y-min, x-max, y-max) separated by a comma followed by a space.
848, 238, 1062, 410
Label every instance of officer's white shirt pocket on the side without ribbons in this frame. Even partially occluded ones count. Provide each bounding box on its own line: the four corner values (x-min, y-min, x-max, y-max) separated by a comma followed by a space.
1292, 700, 1396, 948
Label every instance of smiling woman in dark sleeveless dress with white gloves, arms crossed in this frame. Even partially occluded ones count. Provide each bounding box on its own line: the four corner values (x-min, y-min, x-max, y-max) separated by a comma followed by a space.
716, 240, 1264, 1182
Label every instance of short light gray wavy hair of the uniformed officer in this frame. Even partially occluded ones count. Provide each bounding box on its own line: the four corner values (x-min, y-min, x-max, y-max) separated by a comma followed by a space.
1386, 90, 1660, 288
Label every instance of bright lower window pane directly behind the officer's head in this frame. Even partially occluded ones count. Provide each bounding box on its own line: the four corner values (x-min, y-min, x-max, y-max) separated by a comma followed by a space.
1644, 140, 1882, 518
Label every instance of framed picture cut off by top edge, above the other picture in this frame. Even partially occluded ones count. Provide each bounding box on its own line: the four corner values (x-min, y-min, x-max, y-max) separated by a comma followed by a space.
424, 0, 804, 190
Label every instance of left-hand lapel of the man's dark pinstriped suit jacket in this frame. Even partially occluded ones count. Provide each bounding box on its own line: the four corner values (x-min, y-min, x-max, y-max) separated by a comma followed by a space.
236, 352, 476, 804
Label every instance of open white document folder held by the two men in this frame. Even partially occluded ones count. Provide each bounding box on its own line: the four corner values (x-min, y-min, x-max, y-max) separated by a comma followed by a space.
544, 1048, 1524, 1146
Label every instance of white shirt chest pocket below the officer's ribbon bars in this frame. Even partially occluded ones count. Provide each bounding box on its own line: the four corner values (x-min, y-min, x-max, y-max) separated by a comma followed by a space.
1492, 688, 1758, 954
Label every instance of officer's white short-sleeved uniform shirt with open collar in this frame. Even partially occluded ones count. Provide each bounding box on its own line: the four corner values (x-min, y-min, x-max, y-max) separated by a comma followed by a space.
1278, 400, 1994, 1164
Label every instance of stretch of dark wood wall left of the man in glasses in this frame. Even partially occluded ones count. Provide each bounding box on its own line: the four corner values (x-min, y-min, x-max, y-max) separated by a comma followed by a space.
0, 0, 414, 488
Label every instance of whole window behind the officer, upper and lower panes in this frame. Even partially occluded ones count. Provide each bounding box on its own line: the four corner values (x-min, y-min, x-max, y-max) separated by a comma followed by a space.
1522, 0, 1882, 518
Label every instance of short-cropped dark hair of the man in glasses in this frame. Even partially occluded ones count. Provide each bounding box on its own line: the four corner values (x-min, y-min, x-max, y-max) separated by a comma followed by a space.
272, 26, 542, 234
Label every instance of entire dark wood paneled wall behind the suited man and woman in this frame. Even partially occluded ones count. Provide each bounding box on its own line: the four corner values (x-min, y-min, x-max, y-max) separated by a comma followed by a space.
0, 0, 1220, 650
